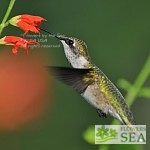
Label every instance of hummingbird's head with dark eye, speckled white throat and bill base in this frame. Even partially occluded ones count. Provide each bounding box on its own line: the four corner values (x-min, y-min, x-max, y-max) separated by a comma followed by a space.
54, 34, 91, 68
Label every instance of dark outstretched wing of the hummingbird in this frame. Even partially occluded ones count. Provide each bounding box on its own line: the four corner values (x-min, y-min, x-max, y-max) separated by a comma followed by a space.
47, 66, 93, 94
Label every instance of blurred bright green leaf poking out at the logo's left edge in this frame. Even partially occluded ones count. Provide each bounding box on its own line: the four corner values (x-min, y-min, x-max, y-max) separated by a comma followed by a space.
83, 126, 95, 144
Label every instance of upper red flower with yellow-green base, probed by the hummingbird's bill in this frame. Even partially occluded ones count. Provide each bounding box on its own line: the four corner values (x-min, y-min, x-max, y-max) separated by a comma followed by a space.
9, 14, 45, 34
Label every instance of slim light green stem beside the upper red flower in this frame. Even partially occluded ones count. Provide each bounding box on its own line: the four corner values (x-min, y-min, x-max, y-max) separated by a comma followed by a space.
0, 0, 16, 35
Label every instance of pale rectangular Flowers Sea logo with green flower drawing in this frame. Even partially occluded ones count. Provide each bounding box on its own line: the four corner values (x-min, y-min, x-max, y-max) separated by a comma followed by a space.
95, 125, 146, 144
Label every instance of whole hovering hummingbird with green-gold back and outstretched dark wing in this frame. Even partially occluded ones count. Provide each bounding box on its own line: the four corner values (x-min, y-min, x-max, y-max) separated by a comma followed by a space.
41, 30, 135, 125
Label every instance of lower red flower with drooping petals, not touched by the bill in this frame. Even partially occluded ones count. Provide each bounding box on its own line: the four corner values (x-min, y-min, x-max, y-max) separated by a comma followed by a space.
0, 36, 38, 55
